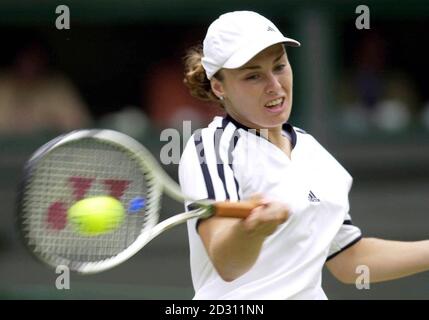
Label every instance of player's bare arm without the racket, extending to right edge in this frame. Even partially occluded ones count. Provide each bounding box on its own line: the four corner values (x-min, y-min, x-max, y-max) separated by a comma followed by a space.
326, 238, 429, 283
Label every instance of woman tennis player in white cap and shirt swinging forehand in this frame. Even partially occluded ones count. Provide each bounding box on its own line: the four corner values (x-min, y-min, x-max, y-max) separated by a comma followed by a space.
179, 11, 429, 299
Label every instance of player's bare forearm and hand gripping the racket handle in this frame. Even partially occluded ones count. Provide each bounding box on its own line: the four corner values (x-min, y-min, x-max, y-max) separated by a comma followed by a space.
198, 196, 289, 281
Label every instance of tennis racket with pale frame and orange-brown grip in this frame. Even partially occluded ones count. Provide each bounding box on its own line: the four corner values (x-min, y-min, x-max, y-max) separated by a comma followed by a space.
18, 129, 258, 273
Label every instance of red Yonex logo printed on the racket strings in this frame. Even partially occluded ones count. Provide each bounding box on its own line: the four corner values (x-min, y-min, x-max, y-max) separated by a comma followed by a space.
46, 176, 130, 230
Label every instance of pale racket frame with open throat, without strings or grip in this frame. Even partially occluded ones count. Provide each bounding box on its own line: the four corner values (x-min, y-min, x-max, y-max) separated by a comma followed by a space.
17, 129, 221, 274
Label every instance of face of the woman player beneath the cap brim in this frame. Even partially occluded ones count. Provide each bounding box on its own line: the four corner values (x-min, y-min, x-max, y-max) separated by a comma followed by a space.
212, 44, 293, 128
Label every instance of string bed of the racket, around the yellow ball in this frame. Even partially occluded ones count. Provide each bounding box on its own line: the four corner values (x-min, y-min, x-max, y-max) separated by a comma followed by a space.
23, 139, 161, 266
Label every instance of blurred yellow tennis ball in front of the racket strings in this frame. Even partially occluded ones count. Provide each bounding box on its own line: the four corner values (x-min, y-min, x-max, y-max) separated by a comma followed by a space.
67, 196, 125, 236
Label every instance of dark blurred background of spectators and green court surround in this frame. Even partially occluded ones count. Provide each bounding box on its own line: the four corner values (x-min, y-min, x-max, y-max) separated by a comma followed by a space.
0, 0, 429, 299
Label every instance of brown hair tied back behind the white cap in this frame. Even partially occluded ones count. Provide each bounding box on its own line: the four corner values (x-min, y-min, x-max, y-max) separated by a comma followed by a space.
183, 45, 222, 103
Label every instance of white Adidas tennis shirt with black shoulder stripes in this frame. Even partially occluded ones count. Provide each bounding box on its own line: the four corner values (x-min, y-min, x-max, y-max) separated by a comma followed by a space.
179, 116, 361, 300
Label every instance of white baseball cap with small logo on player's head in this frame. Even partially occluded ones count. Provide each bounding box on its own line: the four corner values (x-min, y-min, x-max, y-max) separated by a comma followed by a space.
201, 11, 301, 80
